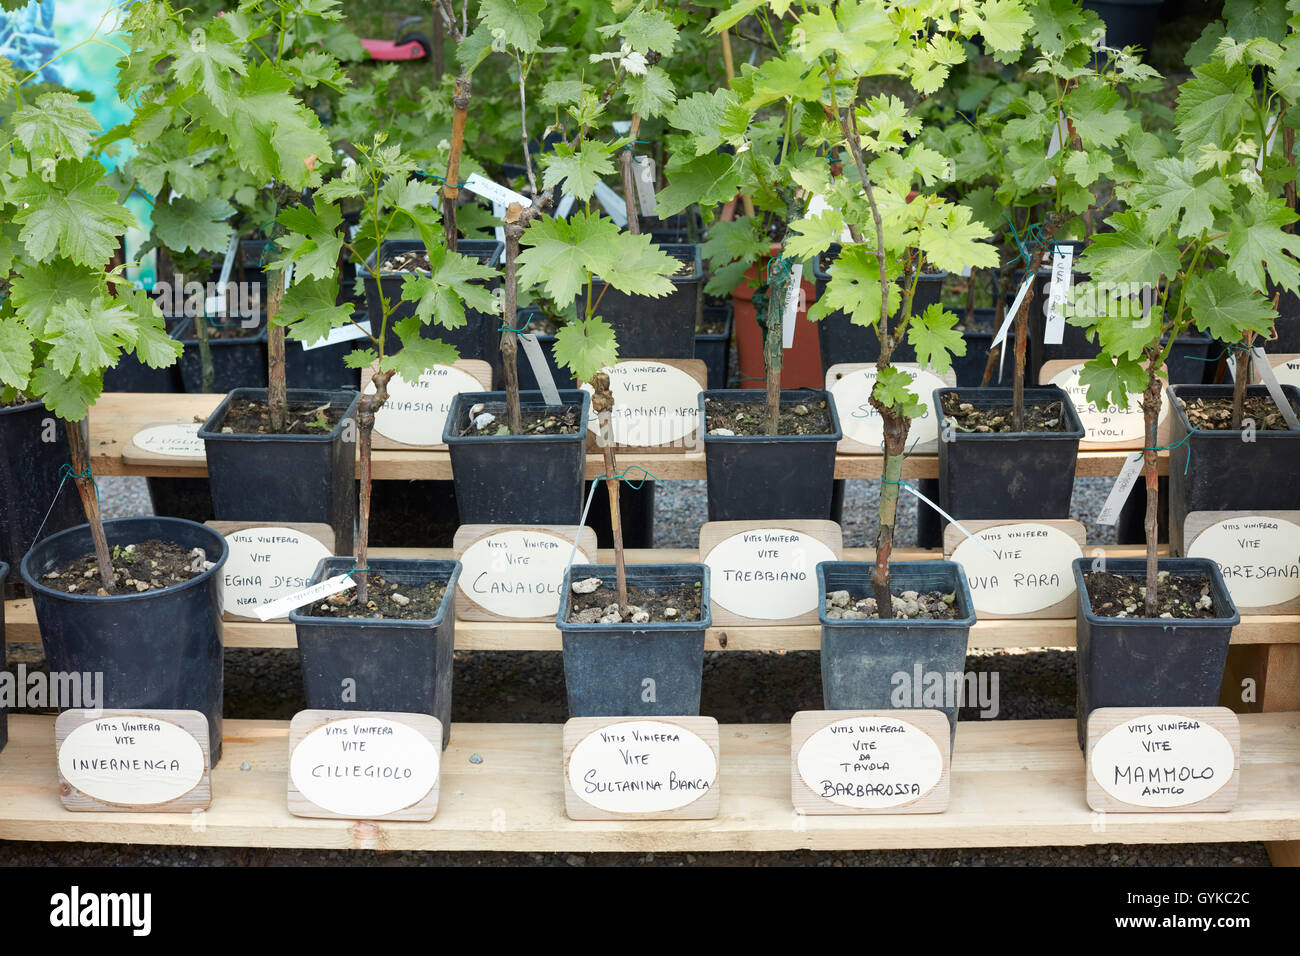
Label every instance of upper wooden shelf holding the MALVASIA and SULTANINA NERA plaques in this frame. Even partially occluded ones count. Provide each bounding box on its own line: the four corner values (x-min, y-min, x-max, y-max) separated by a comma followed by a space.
90, 392, 1169, 481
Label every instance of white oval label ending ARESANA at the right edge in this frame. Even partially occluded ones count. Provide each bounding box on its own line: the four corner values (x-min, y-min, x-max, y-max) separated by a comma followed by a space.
1187, 515, 1300, 607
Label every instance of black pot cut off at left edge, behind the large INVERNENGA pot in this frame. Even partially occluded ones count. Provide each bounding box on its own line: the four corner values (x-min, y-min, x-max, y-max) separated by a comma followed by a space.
0, 402, 86, 600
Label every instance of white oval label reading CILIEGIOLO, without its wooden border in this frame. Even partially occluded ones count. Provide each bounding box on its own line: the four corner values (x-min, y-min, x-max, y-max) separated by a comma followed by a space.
289, 717, 442, 819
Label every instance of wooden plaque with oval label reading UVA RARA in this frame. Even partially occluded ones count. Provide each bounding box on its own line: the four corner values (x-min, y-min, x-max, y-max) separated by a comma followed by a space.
944, 519, 1087, 620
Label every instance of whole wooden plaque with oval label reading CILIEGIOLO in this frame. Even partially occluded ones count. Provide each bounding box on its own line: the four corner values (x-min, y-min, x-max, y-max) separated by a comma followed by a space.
289, 710, 442, 821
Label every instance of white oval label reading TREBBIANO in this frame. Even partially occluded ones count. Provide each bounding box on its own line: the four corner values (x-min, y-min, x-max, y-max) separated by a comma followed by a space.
705, 528, 835, 620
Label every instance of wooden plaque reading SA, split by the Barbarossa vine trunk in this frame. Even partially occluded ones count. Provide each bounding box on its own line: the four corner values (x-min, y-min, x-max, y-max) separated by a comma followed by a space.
826, 362, 957, 455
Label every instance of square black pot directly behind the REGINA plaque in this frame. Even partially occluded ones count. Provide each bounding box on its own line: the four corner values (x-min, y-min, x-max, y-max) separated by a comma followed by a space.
199, 389, 361, 554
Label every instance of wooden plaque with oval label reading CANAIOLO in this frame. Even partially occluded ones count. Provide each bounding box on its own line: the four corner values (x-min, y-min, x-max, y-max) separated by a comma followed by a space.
451, 524, 597, 622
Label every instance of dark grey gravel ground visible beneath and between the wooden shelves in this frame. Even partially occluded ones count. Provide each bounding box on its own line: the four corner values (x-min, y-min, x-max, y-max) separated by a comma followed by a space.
0, 479, 1269, 866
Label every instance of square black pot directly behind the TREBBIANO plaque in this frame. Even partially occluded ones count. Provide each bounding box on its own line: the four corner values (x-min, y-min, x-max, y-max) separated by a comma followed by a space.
699, 389, 844, 522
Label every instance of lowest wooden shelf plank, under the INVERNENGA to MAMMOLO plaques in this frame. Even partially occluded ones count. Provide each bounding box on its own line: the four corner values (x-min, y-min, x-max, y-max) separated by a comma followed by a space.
0, 713, 1300, 853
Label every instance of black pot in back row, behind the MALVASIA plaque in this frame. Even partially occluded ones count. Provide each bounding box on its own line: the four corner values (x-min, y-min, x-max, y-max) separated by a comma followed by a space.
363, 239, 506, 384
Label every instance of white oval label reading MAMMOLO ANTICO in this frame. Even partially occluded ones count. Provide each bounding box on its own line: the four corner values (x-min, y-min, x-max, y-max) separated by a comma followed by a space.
1092, 714, 1236, 806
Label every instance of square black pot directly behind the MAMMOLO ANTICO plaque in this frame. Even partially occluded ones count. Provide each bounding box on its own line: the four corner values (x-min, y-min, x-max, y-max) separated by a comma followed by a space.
1074, 558, 1242, 747
